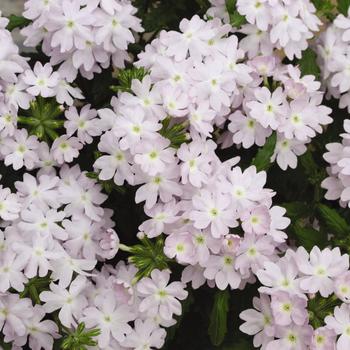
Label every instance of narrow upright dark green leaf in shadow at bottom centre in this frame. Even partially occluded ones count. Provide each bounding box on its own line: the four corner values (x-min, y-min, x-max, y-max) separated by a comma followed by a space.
208, 289, 230, 346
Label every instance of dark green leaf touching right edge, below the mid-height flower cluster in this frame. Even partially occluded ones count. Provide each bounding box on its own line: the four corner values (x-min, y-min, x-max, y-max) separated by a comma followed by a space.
317, 204, 350, 236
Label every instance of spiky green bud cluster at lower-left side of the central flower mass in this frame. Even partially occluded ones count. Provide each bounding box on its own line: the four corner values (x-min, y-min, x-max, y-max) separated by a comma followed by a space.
120, 236, 171, 282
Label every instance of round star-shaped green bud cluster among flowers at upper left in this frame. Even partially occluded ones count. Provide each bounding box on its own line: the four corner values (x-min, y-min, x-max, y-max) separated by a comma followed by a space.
18, 96, 64, 142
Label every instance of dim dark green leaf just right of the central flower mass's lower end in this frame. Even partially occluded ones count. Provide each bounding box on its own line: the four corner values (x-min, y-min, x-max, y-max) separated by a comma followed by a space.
291, 221, 328, 251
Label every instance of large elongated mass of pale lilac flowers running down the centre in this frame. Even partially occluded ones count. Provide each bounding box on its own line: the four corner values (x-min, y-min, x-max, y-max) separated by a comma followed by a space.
94, 17, 298, 289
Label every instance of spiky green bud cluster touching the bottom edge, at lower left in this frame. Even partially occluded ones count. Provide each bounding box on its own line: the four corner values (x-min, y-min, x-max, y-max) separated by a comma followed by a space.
61, 322, 101, 350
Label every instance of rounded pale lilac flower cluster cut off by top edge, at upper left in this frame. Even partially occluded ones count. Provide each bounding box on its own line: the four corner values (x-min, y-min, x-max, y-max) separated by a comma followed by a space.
21, 0, 143, 82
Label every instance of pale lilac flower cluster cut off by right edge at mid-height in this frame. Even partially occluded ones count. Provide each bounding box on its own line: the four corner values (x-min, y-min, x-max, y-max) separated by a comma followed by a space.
322, 119, 350, 207
